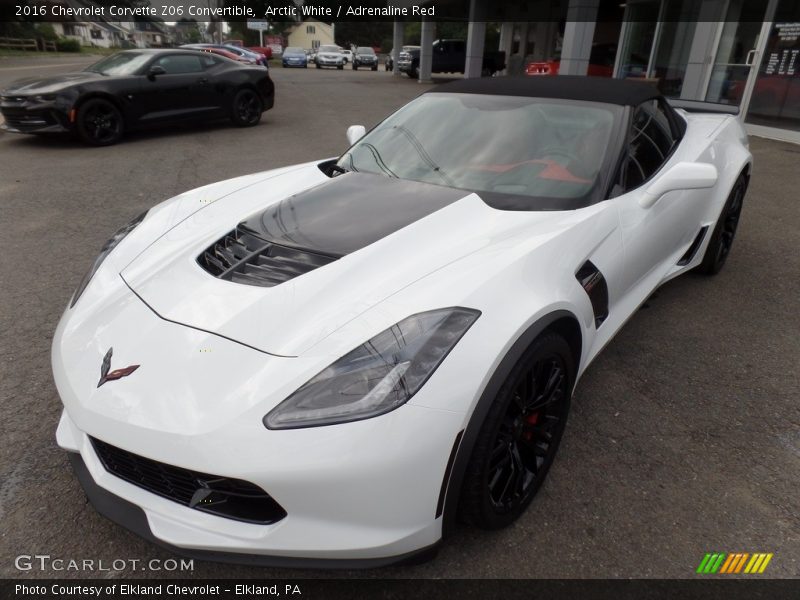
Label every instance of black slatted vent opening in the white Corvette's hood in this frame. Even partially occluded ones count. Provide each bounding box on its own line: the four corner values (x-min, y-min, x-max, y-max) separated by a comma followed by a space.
202, 225, 336, 287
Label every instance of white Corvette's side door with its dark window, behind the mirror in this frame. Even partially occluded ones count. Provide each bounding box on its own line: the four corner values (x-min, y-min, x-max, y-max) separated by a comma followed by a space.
616, 100, 708, 300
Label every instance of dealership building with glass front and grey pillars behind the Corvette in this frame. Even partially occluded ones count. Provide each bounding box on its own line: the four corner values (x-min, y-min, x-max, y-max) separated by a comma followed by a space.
394, 0, 800, 143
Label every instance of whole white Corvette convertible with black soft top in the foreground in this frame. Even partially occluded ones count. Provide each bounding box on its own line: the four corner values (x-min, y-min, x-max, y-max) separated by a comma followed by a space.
53, 76, 752, 567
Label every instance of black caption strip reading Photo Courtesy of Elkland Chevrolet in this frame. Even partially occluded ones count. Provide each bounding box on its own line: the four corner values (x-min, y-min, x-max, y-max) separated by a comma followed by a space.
0, 577, 800, 600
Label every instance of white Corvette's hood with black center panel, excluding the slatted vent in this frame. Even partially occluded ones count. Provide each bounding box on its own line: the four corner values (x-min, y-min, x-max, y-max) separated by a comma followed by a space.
121, 166, 567, 356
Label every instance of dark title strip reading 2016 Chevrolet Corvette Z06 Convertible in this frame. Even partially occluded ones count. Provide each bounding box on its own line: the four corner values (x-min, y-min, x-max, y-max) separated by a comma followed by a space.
0, 0, 800, 23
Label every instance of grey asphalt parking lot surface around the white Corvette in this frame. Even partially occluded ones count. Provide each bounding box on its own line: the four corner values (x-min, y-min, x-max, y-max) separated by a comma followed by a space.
0, 59, 800, 578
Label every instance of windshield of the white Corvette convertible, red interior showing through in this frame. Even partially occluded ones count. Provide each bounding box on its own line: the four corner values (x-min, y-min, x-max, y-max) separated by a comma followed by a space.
338, 93, 622, 209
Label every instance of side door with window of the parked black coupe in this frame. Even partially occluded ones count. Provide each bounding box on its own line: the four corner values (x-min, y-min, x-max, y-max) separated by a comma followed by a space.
140, 52, 213, 123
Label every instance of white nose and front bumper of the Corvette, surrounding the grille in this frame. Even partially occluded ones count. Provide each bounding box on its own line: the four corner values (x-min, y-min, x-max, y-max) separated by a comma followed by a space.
52, 282, 465, 564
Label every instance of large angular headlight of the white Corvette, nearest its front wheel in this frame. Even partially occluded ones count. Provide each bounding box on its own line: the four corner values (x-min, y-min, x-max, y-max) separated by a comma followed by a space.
264, 308, 480, 429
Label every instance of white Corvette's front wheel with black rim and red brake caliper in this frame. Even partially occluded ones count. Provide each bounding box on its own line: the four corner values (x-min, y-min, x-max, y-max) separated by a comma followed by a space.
459, 332, 575, 529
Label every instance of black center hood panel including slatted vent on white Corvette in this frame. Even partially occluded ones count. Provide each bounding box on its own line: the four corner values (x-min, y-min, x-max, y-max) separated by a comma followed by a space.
197, 173, 468, 287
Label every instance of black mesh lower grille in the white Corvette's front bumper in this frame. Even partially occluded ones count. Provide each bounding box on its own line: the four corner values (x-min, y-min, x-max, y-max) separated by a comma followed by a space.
89, 438, 286, 525
